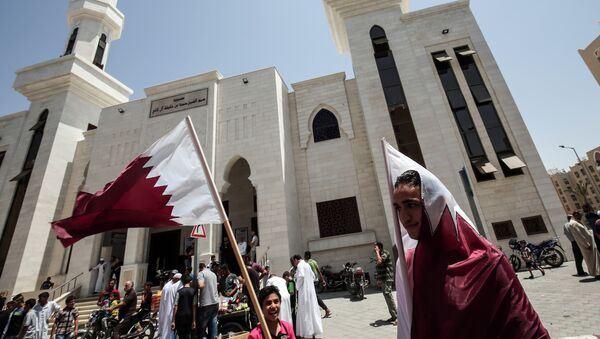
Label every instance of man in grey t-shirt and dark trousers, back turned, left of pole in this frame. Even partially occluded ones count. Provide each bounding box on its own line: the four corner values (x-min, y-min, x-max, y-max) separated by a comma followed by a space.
196, 263, 219, 339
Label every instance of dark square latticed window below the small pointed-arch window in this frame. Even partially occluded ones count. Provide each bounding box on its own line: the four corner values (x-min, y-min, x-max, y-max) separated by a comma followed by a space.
317, 197, 361, 238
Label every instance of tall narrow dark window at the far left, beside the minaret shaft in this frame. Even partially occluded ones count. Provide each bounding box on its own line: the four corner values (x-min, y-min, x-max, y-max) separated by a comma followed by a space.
0, 109, 48, 275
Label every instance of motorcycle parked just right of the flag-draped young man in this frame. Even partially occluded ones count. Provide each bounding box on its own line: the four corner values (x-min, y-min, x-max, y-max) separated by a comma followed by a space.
508, 238, 565, 272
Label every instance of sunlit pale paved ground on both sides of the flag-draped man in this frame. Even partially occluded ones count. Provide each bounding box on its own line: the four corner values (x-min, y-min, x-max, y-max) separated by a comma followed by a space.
322, 262, 600, 339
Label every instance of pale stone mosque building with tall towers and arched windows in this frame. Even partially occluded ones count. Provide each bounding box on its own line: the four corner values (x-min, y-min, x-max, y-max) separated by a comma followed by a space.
0, 0, 565, 294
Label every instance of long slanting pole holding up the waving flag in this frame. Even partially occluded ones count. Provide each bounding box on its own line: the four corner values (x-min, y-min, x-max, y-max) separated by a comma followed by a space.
185, 115, 271, 339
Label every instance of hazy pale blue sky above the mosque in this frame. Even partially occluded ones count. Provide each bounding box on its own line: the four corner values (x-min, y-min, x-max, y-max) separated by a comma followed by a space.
0, 0, 600, 168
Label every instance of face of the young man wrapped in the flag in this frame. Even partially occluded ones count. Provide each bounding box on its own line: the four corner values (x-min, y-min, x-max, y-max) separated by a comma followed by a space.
393, 184, 423, 240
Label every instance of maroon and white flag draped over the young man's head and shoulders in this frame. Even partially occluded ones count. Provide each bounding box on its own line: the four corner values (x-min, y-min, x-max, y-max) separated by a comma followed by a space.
382, 140, 549, 339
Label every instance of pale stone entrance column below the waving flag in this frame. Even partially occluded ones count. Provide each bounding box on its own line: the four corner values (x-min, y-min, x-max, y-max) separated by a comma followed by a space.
119, 228, 149, 290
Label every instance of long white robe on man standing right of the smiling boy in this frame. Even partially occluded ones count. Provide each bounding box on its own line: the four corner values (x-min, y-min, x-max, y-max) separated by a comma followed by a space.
294, 260, 323, 337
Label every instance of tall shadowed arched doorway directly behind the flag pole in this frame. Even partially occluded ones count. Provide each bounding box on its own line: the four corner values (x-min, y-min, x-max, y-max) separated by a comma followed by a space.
220, 158, 260, 271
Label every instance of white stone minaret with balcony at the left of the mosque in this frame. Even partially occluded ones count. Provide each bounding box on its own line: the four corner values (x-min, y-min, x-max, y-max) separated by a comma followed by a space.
0, 0, 133, 294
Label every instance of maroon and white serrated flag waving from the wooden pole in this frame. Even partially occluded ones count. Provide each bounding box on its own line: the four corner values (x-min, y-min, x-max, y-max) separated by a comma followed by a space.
52, 120, 224, 247
